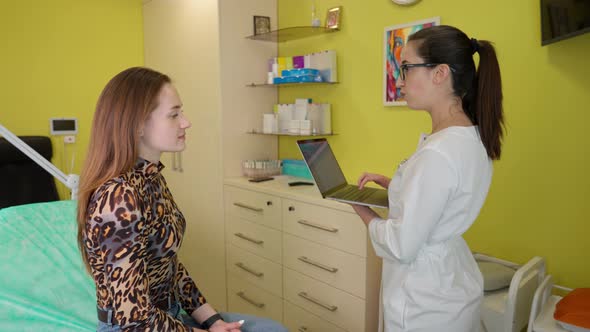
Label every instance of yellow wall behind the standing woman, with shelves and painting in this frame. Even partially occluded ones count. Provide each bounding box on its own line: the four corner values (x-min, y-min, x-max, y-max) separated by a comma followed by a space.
278, 0, 590, 287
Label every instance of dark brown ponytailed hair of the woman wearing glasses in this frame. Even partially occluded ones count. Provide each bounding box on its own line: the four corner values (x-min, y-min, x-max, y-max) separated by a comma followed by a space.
408, 25, 505, 160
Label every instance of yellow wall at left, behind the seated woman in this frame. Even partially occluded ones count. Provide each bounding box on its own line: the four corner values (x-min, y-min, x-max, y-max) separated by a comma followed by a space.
0, 0, 143, 198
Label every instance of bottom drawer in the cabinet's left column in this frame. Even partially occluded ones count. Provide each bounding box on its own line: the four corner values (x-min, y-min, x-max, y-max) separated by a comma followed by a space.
227, 273, 283, 322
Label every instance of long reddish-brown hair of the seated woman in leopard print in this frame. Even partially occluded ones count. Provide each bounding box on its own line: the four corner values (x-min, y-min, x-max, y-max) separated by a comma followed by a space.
78, 67, 170, 272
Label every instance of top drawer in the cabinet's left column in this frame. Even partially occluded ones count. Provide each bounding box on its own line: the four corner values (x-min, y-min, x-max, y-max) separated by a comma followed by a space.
225, 186, 282, 230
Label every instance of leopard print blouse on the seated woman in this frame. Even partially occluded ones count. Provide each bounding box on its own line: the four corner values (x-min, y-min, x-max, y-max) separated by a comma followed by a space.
84, 158, 206, 331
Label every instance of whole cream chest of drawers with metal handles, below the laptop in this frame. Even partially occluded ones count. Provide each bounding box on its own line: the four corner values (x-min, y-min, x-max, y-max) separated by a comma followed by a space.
224, 176, 381, 332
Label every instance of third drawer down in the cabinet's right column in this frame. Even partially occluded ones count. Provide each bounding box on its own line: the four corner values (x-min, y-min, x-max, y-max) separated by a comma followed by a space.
284, 268, 365, 331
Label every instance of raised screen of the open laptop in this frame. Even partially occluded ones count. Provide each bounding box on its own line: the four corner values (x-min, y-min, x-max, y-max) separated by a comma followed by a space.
297, 138, 346, 194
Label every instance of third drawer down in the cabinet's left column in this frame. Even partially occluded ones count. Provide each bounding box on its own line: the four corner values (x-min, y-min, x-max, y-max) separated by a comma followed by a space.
227, 244, 283, 297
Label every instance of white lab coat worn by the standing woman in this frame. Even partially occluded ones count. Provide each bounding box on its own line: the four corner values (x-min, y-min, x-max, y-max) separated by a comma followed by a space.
369, 127, 492, 332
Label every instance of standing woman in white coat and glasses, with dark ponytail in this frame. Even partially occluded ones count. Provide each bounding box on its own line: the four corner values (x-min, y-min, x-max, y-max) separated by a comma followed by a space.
353, 26, 504, 332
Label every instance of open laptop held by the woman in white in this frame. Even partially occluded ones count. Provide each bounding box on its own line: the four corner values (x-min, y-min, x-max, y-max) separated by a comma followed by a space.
297, 138, 389, 208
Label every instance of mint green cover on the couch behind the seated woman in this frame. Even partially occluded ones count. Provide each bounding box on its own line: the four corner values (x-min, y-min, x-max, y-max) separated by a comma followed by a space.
0, 201, 97, 331
